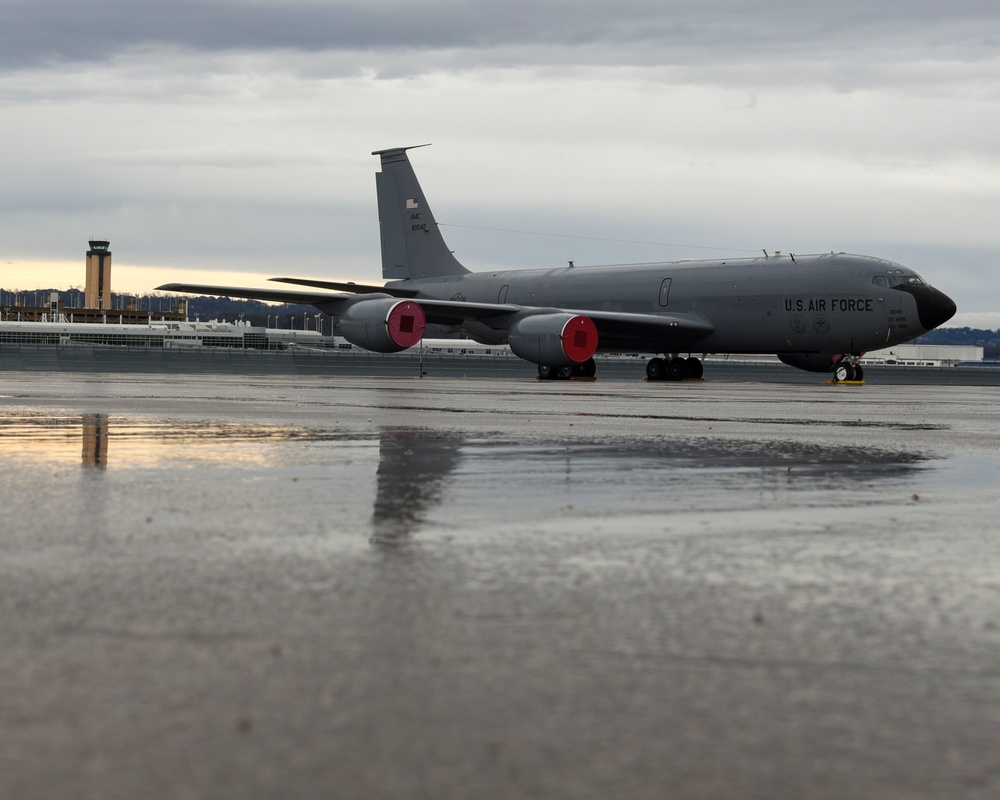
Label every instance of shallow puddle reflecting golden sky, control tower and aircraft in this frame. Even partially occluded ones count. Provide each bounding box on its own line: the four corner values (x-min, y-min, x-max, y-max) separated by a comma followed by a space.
0, 411, 927, 546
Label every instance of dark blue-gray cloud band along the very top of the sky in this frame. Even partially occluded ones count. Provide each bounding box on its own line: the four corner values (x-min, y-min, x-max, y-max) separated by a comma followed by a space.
0, 0, 1000, 74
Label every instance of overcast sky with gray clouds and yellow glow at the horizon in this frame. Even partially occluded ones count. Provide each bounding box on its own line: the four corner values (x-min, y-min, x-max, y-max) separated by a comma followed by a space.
0, 0, 1000, 327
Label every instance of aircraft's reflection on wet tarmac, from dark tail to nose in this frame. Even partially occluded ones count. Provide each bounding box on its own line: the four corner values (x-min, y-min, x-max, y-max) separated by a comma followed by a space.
371, 428, 925, 545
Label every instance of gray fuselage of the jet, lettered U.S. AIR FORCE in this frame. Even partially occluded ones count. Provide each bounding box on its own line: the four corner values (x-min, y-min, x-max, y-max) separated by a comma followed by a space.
389, 253, 953, 353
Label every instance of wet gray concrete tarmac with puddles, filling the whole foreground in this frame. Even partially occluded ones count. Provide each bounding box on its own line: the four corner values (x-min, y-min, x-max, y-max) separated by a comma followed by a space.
0, 373, 1000, 798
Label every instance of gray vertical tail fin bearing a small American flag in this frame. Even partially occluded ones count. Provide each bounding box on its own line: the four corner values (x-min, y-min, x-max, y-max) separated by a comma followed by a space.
372, 145, 469, 280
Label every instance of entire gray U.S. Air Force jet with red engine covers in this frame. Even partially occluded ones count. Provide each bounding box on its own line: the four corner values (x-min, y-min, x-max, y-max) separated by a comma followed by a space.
159, 145, 956, 381
